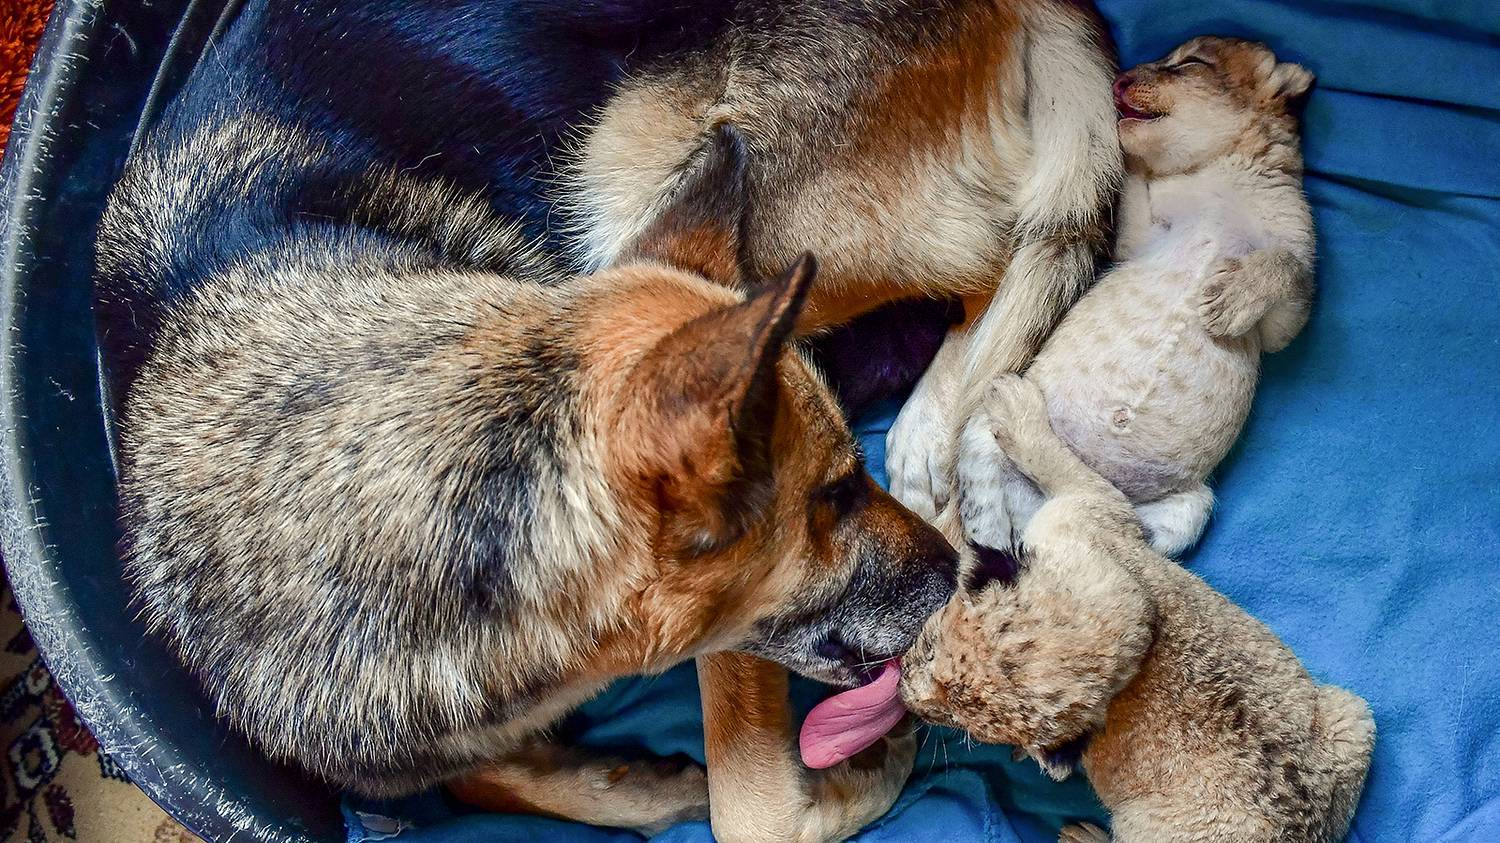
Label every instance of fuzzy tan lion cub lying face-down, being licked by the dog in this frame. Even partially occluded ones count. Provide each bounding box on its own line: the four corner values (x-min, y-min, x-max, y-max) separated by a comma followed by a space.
903, 378, 1374, 843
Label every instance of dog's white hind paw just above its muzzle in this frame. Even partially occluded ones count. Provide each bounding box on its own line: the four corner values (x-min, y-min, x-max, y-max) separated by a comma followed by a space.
885, 389, 954, 521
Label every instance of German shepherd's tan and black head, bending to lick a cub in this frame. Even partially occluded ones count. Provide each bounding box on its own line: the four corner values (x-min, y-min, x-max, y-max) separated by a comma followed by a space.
579, 257, 957, 684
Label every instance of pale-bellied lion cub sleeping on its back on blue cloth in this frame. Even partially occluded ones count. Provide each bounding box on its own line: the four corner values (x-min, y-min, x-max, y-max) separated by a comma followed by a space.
959, 38, 1313, 555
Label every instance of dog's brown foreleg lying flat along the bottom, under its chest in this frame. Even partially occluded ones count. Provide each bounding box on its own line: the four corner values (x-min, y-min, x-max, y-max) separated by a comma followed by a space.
447, 738, 708, 836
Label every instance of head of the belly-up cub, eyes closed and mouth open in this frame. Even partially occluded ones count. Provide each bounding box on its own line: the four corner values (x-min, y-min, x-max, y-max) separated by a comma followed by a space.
1115, 36, 1313, 176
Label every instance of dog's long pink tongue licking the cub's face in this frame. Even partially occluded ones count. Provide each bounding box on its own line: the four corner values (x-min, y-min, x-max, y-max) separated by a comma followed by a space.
800, 659, 906, 770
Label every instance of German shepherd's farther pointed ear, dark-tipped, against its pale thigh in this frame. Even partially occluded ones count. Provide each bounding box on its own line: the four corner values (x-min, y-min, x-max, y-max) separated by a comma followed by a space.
621, 123, 747, 285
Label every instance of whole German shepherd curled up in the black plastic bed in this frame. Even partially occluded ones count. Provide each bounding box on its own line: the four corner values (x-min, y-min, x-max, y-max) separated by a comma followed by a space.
98, 0, 1119, 840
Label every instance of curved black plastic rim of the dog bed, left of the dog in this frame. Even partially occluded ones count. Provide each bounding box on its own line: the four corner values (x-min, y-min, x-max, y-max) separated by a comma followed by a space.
0, 0, 344, 842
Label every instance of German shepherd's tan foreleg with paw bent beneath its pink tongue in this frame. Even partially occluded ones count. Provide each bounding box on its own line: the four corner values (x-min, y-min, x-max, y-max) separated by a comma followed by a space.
698, 653, 917, 843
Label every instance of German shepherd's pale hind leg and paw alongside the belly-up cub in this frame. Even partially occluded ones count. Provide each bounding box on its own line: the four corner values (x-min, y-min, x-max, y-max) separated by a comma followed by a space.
887, 2, 1125, 525
